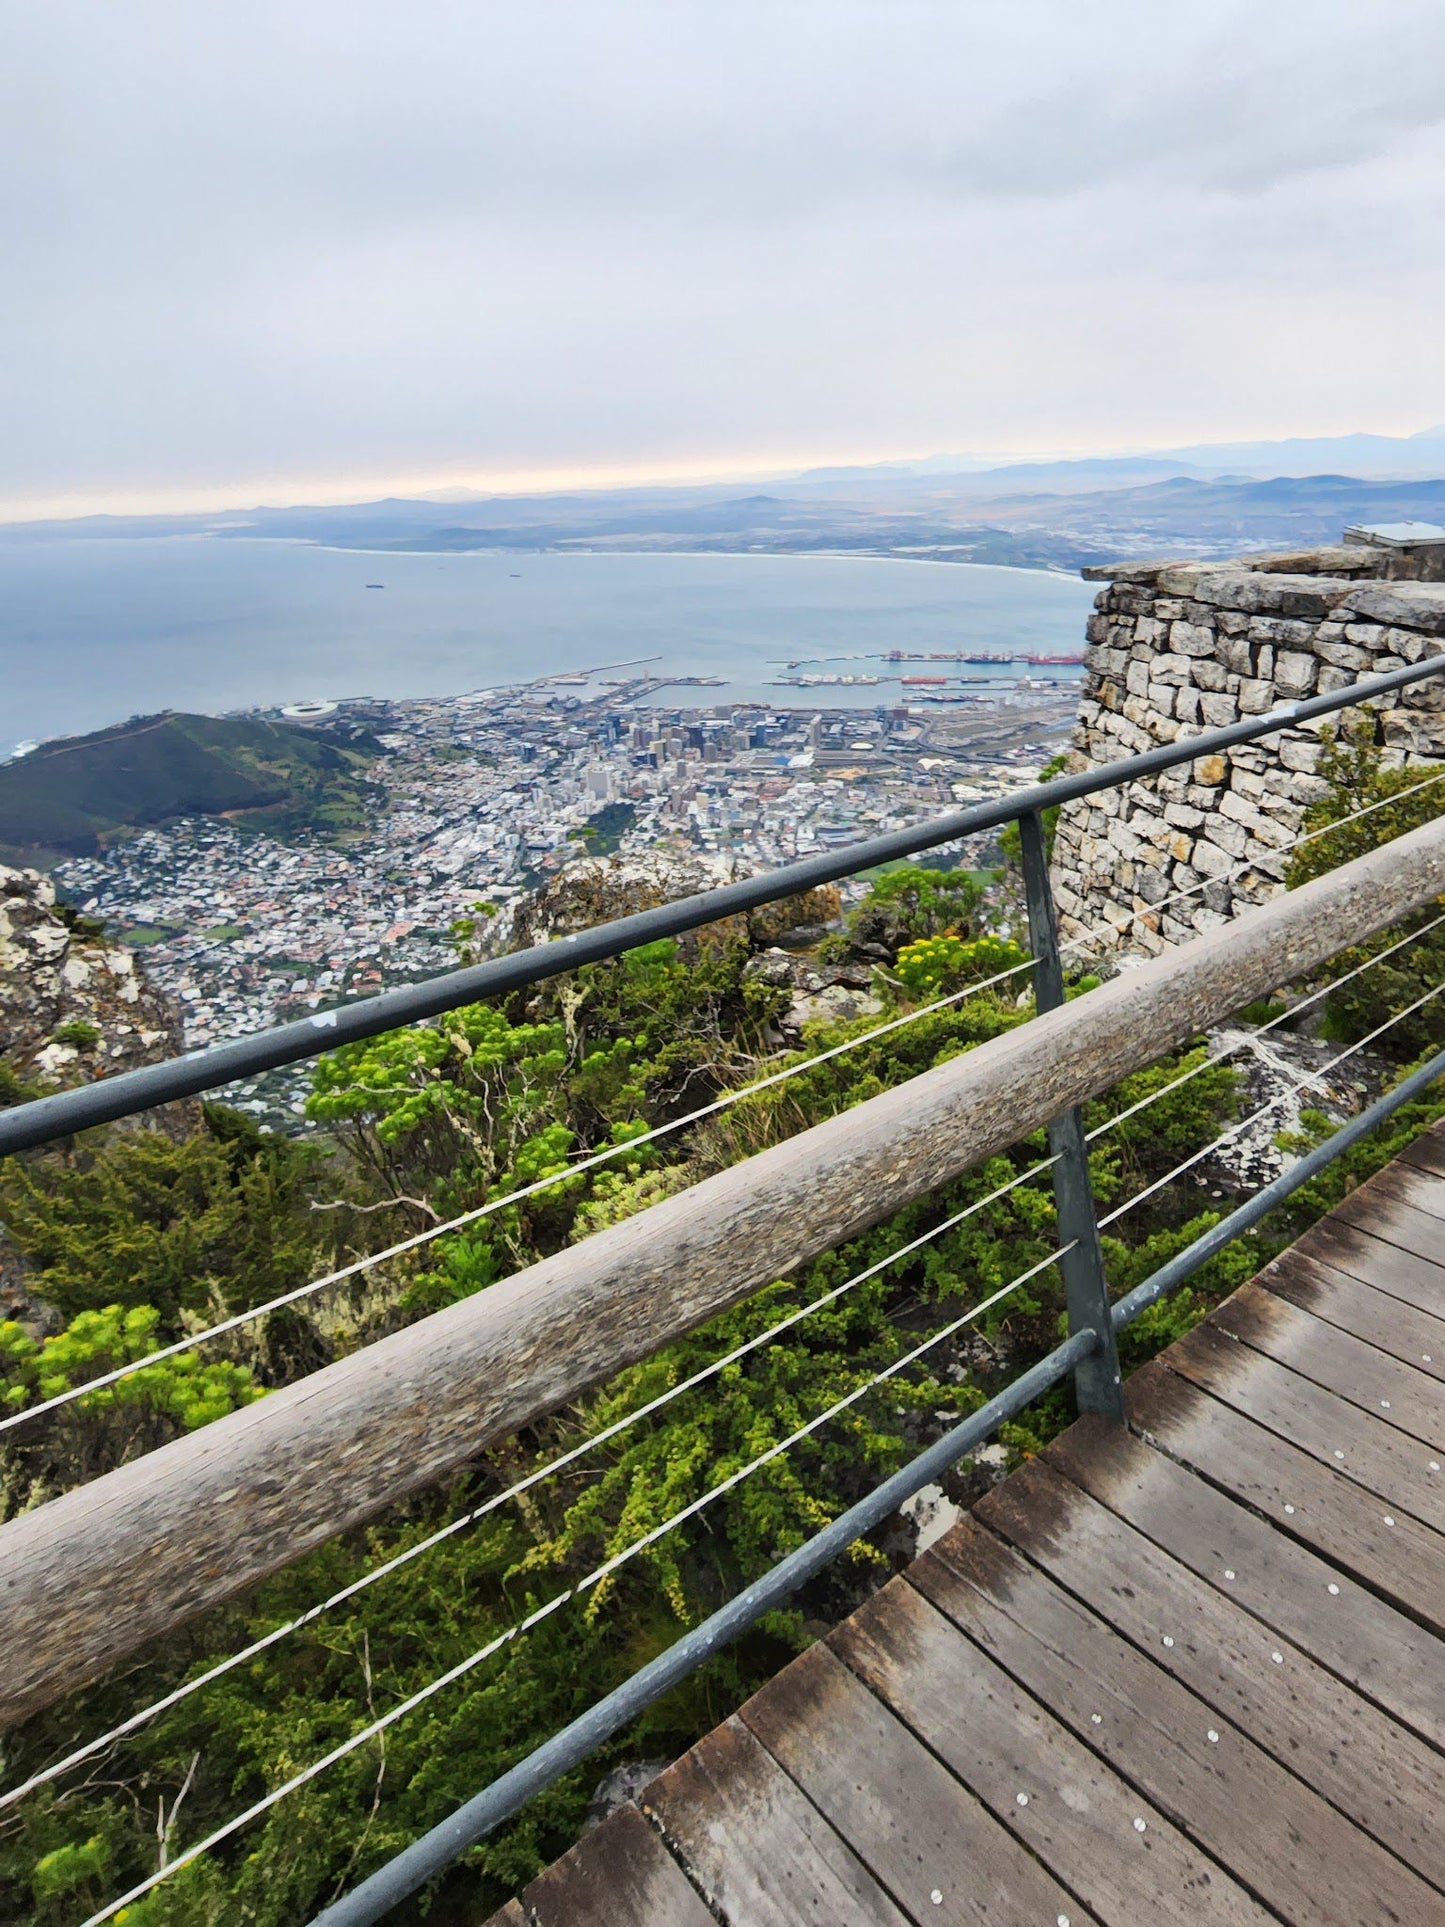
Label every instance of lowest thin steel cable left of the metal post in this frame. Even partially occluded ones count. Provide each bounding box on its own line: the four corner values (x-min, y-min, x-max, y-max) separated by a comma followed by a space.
83, 1243, 1073, 1927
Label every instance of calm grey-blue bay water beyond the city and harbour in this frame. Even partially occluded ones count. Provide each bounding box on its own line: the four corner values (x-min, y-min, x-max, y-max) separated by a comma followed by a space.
0, 536, 1092, 757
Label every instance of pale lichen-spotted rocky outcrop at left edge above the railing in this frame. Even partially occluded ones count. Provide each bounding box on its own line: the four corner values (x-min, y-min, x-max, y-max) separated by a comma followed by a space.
0, 865, 183, 1089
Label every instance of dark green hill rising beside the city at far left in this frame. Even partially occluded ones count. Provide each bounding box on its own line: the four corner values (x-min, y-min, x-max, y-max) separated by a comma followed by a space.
0, 711, 380, 865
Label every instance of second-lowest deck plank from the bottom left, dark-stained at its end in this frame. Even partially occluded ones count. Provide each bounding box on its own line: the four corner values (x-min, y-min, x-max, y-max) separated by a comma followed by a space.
642, 1719, 907, 1927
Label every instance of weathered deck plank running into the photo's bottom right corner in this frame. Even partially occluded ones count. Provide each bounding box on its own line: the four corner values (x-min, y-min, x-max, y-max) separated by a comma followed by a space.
907, 1518, 1441, 1927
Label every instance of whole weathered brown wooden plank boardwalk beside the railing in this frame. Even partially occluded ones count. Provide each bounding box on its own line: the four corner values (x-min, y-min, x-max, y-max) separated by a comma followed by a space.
493, 1127, 1445, 1927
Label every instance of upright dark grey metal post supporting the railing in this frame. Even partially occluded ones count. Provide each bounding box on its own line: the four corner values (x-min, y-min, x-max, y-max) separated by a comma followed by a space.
1019, 811, 1123, 1424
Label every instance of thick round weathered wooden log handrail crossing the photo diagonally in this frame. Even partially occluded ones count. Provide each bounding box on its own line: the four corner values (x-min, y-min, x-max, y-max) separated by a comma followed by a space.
11, 790, 1445, 1725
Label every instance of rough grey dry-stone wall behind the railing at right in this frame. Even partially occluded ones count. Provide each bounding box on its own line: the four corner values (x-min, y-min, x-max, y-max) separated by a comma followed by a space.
1054, 547, 1445, 954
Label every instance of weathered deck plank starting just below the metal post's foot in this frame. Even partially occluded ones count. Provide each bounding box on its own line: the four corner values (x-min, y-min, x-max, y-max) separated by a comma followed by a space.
1044, 1418, 1445, 1746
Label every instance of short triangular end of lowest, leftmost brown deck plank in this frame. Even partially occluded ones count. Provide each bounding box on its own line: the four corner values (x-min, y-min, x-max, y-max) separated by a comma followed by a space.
522, 1806, 715, 1927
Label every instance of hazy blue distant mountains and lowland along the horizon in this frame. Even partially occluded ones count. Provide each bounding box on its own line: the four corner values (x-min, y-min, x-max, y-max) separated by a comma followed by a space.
0, 428, 1445, 568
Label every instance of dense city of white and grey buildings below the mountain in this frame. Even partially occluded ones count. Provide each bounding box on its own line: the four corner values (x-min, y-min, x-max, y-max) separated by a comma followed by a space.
56, 678, 1077, 1108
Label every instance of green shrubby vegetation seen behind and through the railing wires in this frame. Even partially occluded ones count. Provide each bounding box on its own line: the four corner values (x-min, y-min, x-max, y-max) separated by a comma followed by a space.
0, 734, 1445, 1927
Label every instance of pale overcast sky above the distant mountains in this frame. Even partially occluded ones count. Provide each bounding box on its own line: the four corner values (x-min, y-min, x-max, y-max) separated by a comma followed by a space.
0, 0, 1445, 518
